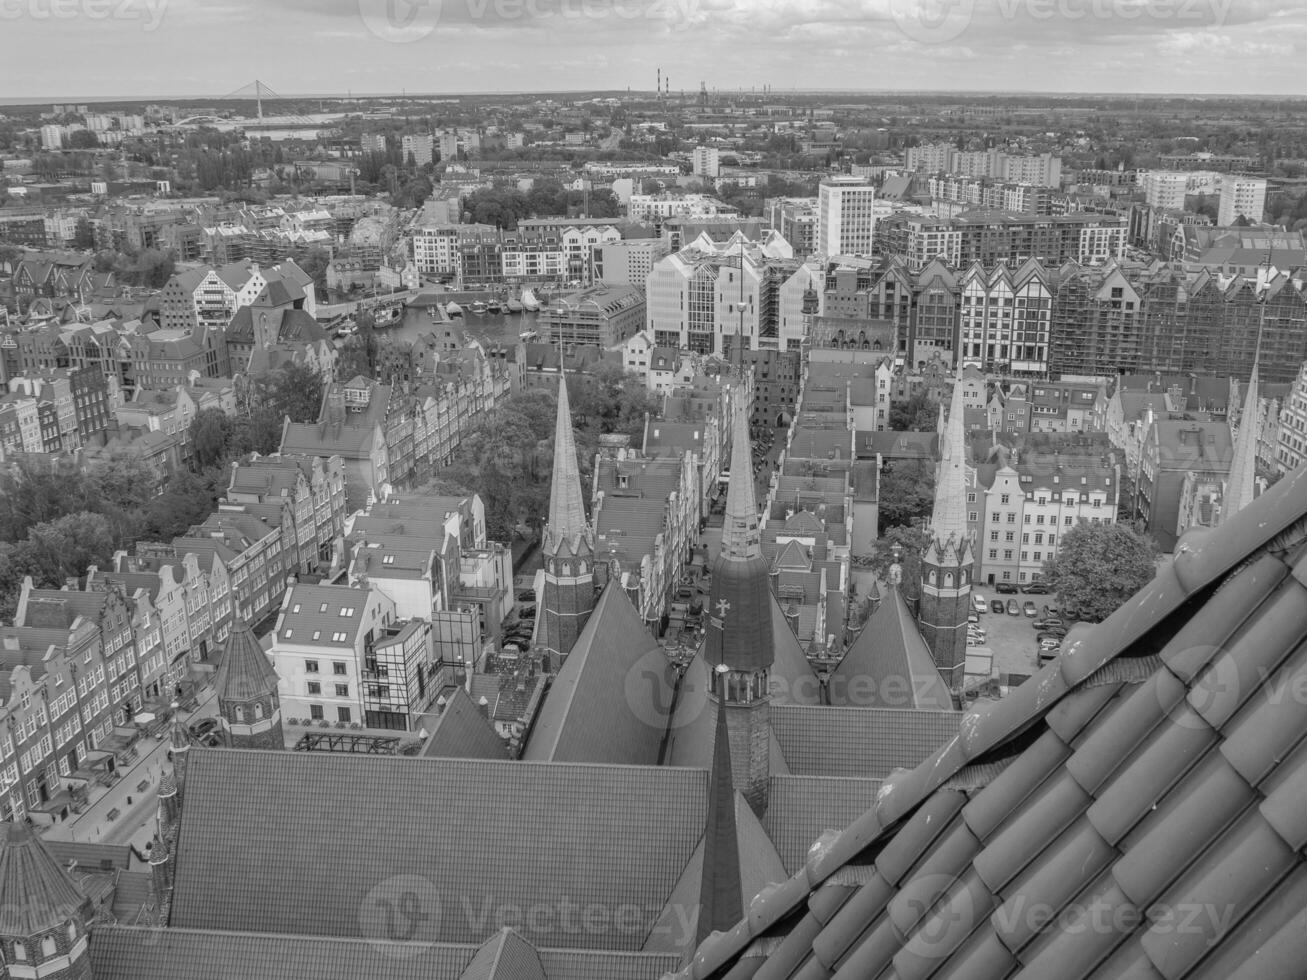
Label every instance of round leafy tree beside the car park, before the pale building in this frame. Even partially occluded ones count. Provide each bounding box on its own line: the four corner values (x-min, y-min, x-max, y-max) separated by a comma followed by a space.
1044, 521, 1157, 623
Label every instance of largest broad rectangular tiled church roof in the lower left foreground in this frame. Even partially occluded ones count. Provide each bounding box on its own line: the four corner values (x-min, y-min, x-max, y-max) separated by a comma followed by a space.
171, 747, 707, 951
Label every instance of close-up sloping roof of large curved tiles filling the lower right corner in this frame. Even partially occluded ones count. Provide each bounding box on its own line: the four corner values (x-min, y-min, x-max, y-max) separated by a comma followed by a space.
682, 468, 1307, 980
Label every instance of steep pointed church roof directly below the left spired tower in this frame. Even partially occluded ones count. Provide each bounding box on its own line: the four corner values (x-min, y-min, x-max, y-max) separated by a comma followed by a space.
523, 580, 674, 766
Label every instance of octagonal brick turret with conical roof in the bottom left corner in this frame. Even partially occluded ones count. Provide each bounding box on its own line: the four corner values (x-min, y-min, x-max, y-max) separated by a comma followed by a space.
0, 823, 93, 980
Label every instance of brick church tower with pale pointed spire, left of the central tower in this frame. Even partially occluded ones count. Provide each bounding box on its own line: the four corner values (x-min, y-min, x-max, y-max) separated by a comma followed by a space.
536, 378, 595, 669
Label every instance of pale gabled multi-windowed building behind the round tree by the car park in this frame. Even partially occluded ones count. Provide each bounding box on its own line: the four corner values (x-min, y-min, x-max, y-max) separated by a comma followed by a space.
967, 456, 1120, 585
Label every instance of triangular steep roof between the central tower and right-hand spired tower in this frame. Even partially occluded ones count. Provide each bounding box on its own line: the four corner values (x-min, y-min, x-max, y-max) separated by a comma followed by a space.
830, 589, 953, 711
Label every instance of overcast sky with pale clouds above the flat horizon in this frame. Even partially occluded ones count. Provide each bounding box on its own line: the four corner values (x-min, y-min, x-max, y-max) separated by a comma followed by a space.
0, 0, 1307, 98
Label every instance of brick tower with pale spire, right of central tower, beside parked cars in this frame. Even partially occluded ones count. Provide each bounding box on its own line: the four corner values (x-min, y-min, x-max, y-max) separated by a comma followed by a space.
919, 363, 975, 693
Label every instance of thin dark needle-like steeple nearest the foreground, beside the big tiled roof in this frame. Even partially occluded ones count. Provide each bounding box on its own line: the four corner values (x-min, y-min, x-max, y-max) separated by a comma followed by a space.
695, 708, 744, 946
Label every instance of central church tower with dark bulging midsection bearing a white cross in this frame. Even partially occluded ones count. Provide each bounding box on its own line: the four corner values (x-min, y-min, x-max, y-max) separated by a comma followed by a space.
703, 394, 775, 817
